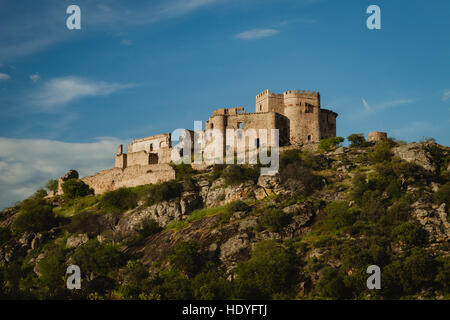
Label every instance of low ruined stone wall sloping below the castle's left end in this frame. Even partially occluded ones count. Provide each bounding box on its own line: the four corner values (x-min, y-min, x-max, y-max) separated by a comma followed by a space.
81, 164, 175, 194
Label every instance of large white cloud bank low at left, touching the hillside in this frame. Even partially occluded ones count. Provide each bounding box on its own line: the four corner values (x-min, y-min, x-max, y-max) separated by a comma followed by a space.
0, 138, 123, 210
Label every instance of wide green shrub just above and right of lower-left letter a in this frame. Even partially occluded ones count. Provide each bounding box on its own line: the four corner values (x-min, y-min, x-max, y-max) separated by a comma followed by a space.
72, 239, 126, 277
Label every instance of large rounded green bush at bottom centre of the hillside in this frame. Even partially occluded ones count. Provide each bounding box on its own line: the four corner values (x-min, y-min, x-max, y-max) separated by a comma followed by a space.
234, 240, 297, 299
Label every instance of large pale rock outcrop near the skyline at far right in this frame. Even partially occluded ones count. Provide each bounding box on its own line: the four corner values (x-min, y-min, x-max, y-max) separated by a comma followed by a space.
392, 142, 436, 172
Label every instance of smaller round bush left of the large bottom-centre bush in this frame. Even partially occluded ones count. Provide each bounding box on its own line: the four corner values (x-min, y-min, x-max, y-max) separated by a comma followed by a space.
169, 240, 204, 277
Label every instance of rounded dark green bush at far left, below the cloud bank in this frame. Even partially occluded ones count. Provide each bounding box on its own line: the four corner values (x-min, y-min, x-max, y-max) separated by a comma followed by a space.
12, 199, 58, 233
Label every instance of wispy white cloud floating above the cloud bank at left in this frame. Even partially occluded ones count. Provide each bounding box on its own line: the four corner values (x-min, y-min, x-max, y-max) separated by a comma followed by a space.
30, 77, 134, 111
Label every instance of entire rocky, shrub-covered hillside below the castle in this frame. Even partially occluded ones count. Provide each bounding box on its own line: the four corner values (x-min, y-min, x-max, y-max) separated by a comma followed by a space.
0, 141, 450, 299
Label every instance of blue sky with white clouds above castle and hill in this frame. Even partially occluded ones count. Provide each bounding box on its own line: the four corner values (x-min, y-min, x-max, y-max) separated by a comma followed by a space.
0, 0, 450, 207
